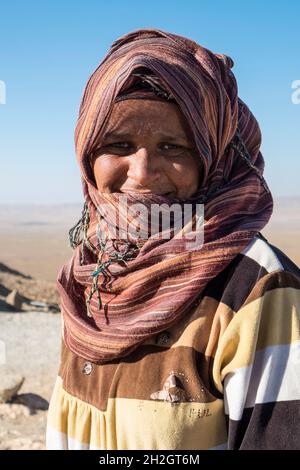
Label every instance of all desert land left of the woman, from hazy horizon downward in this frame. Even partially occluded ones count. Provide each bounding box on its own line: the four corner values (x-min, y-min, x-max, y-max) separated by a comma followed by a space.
0, 204, 82, 450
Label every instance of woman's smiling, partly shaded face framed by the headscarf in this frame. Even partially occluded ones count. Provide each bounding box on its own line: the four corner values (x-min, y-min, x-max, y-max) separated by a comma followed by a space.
92, 99, 200, 198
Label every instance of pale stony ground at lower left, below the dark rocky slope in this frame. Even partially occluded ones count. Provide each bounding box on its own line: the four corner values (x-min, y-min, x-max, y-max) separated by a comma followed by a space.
0, 312, 61, 450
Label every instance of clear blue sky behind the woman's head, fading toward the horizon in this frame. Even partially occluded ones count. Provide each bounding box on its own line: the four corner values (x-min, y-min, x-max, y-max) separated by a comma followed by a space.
0, 0, 300, 203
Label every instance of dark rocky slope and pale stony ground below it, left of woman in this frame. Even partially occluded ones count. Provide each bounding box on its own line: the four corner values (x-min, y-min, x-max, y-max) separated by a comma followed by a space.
0, 263, 61, 450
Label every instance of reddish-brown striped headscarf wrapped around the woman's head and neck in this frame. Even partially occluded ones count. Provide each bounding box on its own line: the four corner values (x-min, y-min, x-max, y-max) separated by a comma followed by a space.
57, 29, 273, 364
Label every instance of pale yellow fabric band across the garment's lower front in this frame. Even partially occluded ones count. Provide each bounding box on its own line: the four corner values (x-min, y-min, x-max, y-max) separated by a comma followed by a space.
48, 377, 227, 450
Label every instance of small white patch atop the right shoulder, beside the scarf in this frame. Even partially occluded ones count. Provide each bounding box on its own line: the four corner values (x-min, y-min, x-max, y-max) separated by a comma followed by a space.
242, 237, 283, 273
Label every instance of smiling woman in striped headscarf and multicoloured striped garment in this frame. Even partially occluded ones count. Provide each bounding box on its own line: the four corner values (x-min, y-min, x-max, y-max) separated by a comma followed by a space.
47, 29, 300, 450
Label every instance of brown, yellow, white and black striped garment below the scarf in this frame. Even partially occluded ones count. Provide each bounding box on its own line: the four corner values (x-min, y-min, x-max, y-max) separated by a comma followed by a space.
47, 234, 300, 450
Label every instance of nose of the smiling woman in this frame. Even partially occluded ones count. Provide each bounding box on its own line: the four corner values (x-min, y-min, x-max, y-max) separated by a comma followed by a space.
127, 147, 159, 186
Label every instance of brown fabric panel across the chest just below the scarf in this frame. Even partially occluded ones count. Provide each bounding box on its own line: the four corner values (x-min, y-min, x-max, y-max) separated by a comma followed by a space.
59, 338, 220, 411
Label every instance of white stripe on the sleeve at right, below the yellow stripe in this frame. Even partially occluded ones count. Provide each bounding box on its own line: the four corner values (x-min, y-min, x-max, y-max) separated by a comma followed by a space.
224, 341, 300, 421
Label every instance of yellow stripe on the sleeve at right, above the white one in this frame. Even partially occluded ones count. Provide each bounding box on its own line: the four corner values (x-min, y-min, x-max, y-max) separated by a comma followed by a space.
213, 287, 300, 393
